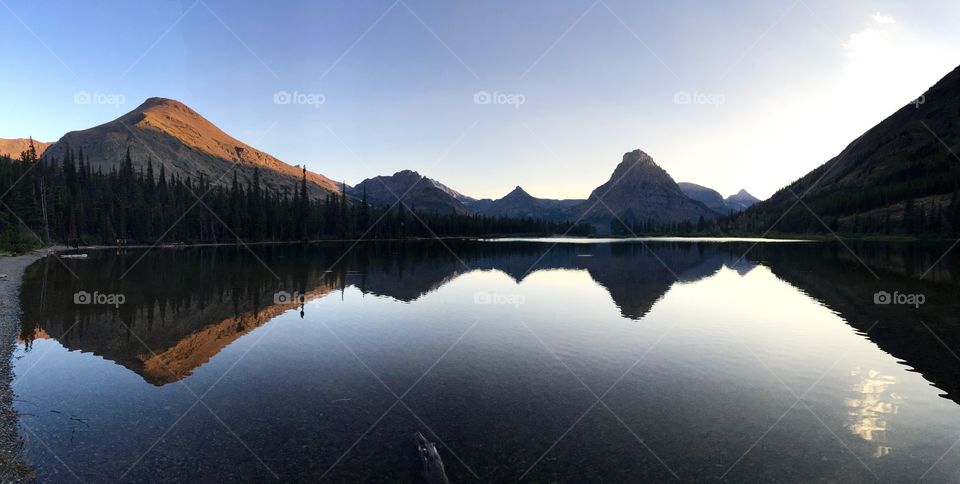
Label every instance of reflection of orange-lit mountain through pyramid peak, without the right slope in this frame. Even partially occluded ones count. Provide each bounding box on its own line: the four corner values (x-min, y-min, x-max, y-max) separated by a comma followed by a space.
21, 244, 736, 385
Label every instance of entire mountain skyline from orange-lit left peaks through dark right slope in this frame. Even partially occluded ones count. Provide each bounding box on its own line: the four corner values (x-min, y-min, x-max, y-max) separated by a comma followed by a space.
7, 64, 960, 238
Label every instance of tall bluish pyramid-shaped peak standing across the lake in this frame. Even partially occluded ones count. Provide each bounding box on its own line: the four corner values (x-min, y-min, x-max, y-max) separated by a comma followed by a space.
577, 150, 717, 232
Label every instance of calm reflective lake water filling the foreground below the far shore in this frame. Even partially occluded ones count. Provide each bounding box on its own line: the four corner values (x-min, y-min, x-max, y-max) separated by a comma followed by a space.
14, 240, 960, 482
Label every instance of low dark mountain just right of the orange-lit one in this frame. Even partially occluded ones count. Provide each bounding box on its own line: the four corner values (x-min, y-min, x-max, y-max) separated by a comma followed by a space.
347, 170, 472, 214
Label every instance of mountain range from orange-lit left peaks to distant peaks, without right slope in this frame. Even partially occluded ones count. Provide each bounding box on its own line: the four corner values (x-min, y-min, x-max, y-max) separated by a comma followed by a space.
0, 97, 755, 232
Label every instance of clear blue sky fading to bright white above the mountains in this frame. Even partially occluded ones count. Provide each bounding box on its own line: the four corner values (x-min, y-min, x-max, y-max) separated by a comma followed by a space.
0, 0, 960, 198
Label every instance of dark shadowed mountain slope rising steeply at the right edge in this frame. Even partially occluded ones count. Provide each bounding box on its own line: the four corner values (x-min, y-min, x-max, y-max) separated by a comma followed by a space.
739, 67, 960, 234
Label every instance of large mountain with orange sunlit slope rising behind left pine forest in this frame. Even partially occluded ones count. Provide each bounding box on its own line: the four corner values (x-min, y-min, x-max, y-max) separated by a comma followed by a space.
43, 97, 339, 196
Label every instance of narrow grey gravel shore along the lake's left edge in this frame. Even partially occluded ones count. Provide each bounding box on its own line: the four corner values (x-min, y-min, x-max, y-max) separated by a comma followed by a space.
0, 250, 47, 482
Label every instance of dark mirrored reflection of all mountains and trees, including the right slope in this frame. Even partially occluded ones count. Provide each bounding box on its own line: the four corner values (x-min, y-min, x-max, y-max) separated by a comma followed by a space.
21, 242, 960, 402
